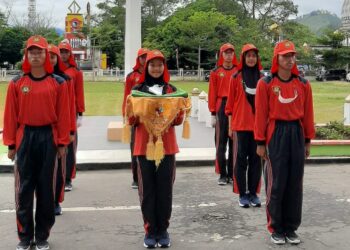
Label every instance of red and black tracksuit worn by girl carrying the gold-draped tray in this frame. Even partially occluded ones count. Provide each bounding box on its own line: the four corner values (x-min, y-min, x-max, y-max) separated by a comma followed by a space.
129, 83, 184, 235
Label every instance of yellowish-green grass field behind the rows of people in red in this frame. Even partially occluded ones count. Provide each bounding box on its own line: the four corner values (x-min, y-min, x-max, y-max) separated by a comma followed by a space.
0, 81, 350, 127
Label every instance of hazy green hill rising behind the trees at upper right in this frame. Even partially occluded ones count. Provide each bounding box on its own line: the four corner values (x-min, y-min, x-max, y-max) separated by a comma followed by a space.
296, 10, 341, 36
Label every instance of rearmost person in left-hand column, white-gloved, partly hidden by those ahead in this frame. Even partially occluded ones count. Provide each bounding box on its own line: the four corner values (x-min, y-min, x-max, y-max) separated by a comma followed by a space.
58, 41, 85, 191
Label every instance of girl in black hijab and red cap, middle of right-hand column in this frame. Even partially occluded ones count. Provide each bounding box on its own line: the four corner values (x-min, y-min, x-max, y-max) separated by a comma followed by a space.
225, 44, 262, 208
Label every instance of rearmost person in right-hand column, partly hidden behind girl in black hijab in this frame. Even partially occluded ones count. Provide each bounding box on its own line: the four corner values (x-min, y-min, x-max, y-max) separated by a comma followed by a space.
208, 43, 237, 185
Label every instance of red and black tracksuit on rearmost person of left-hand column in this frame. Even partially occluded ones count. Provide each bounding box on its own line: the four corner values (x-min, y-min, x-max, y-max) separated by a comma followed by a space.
64, 66, 85, 182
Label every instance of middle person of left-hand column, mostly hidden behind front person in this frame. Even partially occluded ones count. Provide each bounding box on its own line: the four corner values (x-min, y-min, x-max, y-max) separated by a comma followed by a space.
49, 44, 77, 215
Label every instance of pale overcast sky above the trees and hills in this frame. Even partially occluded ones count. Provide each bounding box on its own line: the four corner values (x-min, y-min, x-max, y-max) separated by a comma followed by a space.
0, 0, 343, 29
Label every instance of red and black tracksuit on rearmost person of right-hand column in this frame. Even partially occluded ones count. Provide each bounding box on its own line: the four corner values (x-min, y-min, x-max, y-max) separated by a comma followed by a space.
208, 66, 237, 178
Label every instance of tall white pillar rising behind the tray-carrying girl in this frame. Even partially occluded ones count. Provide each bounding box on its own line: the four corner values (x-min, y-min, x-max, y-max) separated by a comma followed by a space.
124, 0, 141, 79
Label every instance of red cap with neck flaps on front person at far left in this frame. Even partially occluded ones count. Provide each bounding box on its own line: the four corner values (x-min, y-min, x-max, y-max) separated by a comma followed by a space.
22, 35, 53, 74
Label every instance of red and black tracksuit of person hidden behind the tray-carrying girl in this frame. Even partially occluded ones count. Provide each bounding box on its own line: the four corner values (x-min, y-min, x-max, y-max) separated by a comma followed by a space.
122, 70, 141, 182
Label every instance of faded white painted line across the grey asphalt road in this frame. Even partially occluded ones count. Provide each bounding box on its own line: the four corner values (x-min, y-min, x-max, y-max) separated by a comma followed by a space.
0, 202, 218, 214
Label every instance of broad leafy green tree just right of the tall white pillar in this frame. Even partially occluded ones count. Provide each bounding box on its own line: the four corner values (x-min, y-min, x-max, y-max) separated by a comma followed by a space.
144, 10, 238, 68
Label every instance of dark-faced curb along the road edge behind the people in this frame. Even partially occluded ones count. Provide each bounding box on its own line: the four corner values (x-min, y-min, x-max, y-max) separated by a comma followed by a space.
0, 157, 350, 173
